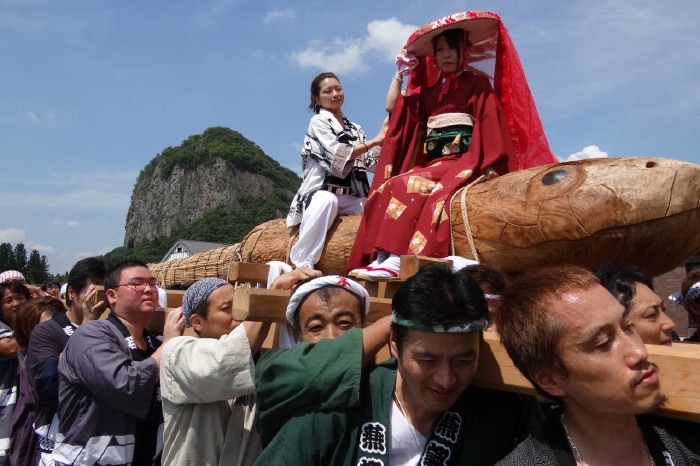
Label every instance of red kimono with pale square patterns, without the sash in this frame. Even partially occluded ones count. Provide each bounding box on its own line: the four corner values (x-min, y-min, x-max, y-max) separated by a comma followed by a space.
348, 71, 508, 269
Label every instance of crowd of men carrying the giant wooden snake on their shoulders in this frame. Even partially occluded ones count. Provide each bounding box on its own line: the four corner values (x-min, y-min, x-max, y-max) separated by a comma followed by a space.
0, 258, 700, 466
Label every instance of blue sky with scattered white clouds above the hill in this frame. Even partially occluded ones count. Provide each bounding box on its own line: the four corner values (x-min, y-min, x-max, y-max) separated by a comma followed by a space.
0, 0, 700, 273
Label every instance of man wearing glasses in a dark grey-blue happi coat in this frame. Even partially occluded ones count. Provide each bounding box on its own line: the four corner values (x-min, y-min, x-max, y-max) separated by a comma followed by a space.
53, 261, 184, 465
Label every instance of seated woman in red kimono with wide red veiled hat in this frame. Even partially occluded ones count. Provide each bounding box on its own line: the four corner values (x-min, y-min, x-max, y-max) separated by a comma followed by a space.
349, 12, 556, 278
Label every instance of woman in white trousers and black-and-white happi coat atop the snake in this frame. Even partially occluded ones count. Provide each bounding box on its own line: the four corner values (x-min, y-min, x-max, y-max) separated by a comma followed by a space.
287, 72, 386, 268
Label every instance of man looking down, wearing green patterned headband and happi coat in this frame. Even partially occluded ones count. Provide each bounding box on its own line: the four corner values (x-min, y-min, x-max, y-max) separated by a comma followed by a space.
256, 264, 541, 466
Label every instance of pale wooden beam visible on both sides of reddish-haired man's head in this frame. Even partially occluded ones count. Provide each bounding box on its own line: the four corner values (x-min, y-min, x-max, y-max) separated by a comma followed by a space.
474, 332, 700, 422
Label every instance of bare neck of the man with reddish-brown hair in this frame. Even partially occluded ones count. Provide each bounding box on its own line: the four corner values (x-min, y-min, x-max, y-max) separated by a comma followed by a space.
562, 406, 649, 466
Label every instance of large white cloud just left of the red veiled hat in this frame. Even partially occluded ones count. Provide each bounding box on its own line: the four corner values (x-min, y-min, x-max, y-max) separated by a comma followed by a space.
292, 18, 417, 73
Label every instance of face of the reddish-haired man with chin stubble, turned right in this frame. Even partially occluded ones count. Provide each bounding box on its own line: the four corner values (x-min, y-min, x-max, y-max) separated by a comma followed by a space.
538, 285, 664, 415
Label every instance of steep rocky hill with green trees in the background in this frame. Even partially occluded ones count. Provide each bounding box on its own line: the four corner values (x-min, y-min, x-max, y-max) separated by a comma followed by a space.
107, 127, 301, 263
